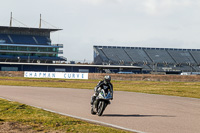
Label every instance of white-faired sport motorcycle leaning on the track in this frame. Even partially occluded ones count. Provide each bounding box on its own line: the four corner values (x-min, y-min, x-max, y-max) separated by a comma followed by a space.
91, 89, 112, 116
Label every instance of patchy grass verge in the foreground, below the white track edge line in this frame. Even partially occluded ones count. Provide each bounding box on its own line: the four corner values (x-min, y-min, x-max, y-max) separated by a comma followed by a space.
0, 99, 130, 133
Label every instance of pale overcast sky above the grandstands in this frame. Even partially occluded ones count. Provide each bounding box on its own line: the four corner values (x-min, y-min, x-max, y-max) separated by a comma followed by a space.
0, 0, 200, 62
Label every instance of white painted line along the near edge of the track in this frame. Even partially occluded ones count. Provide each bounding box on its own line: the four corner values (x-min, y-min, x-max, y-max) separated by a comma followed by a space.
0, 97, 145, 133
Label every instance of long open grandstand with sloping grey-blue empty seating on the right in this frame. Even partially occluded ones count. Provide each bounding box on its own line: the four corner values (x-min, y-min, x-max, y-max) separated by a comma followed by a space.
93, 46, 200, 73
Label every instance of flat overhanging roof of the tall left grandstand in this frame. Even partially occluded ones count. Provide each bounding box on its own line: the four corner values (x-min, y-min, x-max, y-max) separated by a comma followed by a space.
0, 26, 62, 32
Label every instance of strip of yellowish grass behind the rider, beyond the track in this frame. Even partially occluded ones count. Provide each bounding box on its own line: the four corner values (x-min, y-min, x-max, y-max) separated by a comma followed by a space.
0, 77, 200, 98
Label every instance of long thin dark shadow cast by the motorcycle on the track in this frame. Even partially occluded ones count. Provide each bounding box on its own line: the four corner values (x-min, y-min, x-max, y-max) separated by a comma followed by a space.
103, 114, 175, 117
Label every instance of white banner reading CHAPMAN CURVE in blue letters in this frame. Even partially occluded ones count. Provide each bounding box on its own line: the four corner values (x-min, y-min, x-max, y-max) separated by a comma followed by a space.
24, 71, 88, 79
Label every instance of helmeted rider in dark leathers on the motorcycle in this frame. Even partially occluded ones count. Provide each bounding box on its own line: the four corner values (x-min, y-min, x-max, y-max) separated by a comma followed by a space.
91, 75, 113, 105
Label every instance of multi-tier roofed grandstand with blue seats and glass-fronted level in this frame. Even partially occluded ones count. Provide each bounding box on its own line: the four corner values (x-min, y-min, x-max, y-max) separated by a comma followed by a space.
0, 26, 66, 63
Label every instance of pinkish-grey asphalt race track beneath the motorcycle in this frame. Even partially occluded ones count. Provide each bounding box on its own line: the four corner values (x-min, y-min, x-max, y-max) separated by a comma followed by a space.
0, 86, 200, 133
